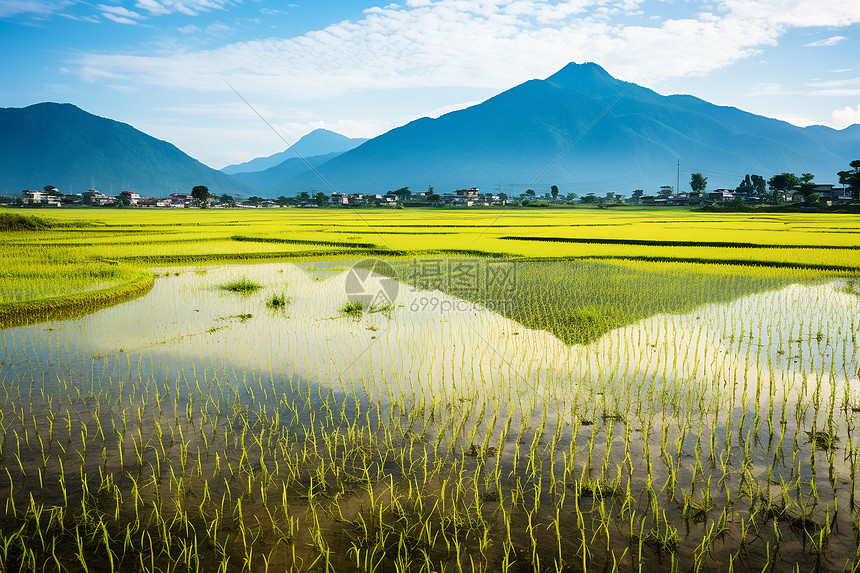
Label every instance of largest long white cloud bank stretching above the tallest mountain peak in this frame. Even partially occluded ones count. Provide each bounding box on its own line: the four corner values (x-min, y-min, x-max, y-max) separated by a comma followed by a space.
65, 0, 808, 97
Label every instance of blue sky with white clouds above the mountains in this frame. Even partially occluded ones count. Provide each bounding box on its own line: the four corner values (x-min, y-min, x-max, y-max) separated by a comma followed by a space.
0, 0, 860, 168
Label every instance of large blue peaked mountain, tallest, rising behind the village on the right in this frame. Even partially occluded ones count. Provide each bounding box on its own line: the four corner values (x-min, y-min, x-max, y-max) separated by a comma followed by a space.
281, 63, 860, 195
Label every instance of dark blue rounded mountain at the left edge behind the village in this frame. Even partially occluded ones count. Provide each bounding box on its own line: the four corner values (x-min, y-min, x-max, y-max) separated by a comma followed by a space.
0, 103, 257, 196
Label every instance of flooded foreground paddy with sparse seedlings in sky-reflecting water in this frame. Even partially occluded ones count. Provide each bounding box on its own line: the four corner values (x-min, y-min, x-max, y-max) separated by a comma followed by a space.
0, 261, 860, 573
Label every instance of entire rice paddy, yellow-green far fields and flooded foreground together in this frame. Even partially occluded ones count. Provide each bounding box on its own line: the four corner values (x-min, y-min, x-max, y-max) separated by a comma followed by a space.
0, 209, 860, 573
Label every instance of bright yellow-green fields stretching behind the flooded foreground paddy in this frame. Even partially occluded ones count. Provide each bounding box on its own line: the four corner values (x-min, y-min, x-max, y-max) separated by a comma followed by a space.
0, 208, 860, 332
